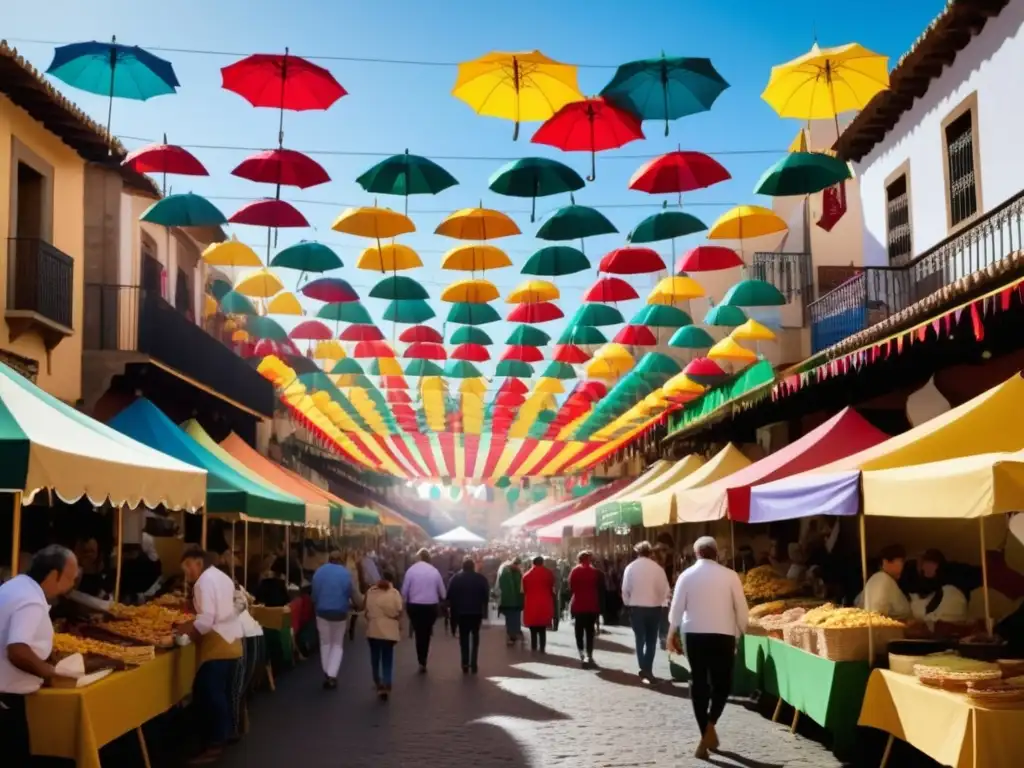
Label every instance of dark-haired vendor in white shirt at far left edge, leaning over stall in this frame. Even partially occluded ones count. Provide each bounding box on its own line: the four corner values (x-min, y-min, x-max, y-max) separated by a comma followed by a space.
0, 546, 78, 766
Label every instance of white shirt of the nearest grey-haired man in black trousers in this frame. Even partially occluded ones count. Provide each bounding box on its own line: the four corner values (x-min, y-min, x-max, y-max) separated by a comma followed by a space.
669, 558, 748, 637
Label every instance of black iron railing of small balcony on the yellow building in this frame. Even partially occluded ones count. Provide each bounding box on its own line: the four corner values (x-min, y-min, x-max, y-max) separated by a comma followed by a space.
7, 238, 75, 328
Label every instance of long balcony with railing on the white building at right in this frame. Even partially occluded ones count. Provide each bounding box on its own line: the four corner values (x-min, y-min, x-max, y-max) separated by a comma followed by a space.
809, 191, 1024, 352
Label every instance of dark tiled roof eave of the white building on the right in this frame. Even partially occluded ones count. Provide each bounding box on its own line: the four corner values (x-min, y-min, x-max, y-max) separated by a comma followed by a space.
836, 0, 1010, 161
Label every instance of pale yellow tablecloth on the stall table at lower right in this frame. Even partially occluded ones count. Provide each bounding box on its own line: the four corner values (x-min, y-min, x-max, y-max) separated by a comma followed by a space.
858, 670, 1024, 768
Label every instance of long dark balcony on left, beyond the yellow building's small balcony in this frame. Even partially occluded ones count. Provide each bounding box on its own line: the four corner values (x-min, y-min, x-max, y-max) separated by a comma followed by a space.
83, 284, 274, 416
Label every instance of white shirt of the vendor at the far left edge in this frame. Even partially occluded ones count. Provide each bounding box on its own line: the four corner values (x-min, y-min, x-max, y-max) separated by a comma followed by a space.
0, 575, 53, 693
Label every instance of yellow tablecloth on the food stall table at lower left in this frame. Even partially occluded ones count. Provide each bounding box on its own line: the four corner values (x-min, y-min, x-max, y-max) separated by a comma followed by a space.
28, 645, 196, 768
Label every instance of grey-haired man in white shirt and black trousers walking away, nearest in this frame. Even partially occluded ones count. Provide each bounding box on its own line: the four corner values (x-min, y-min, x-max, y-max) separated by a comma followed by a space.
669, 536, 749, 760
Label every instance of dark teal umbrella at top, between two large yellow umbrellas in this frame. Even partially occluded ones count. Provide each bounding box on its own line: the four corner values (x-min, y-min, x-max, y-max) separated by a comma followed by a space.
601, 53, 729, 136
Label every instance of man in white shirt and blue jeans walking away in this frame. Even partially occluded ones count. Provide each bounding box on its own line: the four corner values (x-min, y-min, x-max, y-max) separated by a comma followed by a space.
623, 542, 672, 685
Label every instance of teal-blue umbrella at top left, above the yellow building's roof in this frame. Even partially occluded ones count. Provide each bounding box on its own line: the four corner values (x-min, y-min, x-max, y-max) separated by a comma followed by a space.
46, 37, 180, 143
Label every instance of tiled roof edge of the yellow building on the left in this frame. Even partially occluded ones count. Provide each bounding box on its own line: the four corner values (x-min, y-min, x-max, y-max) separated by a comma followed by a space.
0, 40, 161, 198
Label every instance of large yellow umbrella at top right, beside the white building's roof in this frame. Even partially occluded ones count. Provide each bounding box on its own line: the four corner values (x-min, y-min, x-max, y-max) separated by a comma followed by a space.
761, 43, 889, 120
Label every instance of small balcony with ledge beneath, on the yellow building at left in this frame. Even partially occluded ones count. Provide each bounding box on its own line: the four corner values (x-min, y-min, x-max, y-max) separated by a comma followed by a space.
5, 238, 75, 349
